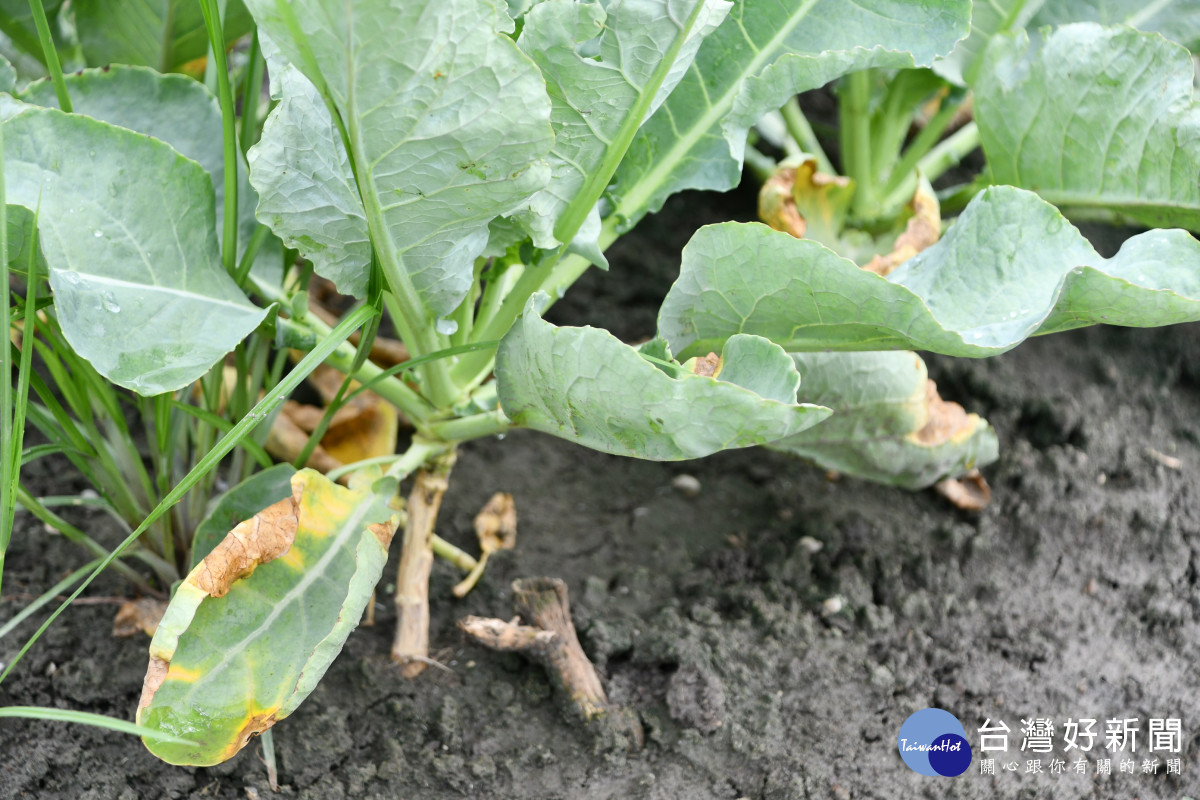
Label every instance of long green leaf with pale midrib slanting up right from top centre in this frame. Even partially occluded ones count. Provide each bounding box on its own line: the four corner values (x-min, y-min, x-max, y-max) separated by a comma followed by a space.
613, 0, 971, 225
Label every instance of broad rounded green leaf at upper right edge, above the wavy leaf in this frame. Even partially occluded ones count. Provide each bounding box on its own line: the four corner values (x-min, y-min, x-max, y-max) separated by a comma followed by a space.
976, 23, 1200, 230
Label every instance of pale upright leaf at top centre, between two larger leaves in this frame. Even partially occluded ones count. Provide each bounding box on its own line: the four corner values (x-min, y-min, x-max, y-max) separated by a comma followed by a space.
518, 0, 732, 253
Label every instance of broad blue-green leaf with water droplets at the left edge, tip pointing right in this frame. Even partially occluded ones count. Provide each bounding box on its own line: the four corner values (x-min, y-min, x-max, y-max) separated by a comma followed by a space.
4, 106, 265, 396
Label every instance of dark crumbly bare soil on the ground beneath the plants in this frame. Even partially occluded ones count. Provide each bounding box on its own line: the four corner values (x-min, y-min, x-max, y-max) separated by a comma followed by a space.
0, 189, 1200, 800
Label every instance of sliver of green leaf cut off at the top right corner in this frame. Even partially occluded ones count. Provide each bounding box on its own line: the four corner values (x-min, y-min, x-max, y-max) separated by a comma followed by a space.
1032, 0, 1200, 52
